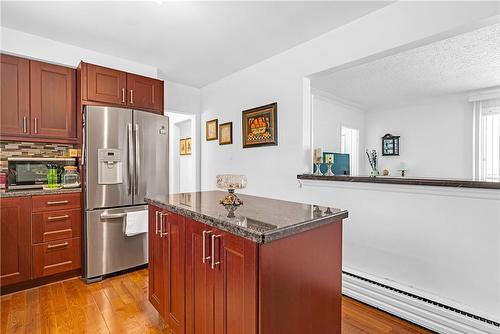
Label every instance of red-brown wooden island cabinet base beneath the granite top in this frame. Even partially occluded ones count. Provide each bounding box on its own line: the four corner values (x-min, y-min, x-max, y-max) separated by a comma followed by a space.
149, 206, 342, 334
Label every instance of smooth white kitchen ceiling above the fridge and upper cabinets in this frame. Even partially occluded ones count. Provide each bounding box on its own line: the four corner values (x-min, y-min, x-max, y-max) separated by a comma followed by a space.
1, 1, 389, 87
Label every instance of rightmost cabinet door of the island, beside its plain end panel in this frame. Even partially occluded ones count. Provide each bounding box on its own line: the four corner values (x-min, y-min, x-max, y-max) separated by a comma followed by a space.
211, 231, 257, 334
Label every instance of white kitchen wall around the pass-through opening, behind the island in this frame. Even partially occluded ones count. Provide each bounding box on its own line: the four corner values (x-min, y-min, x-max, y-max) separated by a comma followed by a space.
201, 2, 500, 320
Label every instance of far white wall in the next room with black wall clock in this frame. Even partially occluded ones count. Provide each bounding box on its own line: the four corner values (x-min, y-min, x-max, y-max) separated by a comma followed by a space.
364, 94, 473, 179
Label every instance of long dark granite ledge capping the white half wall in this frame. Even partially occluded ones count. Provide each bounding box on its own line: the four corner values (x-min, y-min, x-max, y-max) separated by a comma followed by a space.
297, 174, 500, 189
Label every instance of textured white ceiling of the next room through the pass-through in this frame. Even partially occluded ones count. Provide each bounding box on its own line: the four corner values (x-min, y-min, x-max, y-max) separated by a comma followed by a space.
311, 24, 500, 109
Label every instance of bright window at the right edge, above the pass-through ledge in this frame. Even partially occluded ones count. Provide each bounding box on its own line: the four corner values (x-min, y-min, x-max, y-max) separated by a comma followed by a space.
479, 105, 500, 182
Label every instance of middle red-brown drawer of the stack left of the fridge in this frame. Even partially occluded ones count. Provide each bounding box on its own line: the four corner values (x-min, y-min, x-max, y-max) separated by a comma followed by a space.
31, 209, 82, 244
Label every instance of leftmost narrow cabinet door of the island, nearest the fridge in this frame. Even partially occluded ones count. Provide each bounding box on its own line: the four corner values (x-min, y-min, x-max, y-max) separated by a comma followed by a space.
148, 205, 165, 315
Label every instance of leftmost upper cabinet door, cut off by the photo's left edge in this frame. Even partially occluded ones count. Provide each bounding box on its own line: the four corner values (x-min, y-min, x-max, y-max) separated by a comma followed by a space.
0, 55, 30, 136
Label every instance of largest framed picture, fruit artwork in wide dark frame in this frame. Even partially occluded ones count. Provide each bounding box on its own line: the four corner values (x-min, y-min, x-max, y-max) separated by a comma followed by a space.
241, 102, 278, 148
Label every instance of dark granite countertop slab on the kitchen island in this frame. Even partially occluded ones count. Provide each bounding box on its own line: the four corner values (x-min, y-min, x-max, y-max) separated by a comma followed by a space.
146, 191, 348, 243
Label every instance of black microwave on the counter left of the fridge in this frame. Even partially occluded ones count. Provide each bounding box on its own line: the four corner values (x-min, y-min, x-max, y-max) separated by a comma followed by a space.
7, 157, 76, 190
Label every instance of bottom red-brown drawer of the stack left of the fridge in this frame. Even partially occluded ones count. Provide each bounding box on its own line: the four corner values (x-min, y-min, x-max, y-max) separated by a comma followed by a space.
33, 238, 81, 278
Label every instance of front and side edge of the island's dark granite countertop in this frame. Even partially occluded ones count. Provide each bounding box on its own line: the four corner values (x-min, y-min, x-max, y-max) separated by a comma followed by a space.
144, 197, 348, 244
